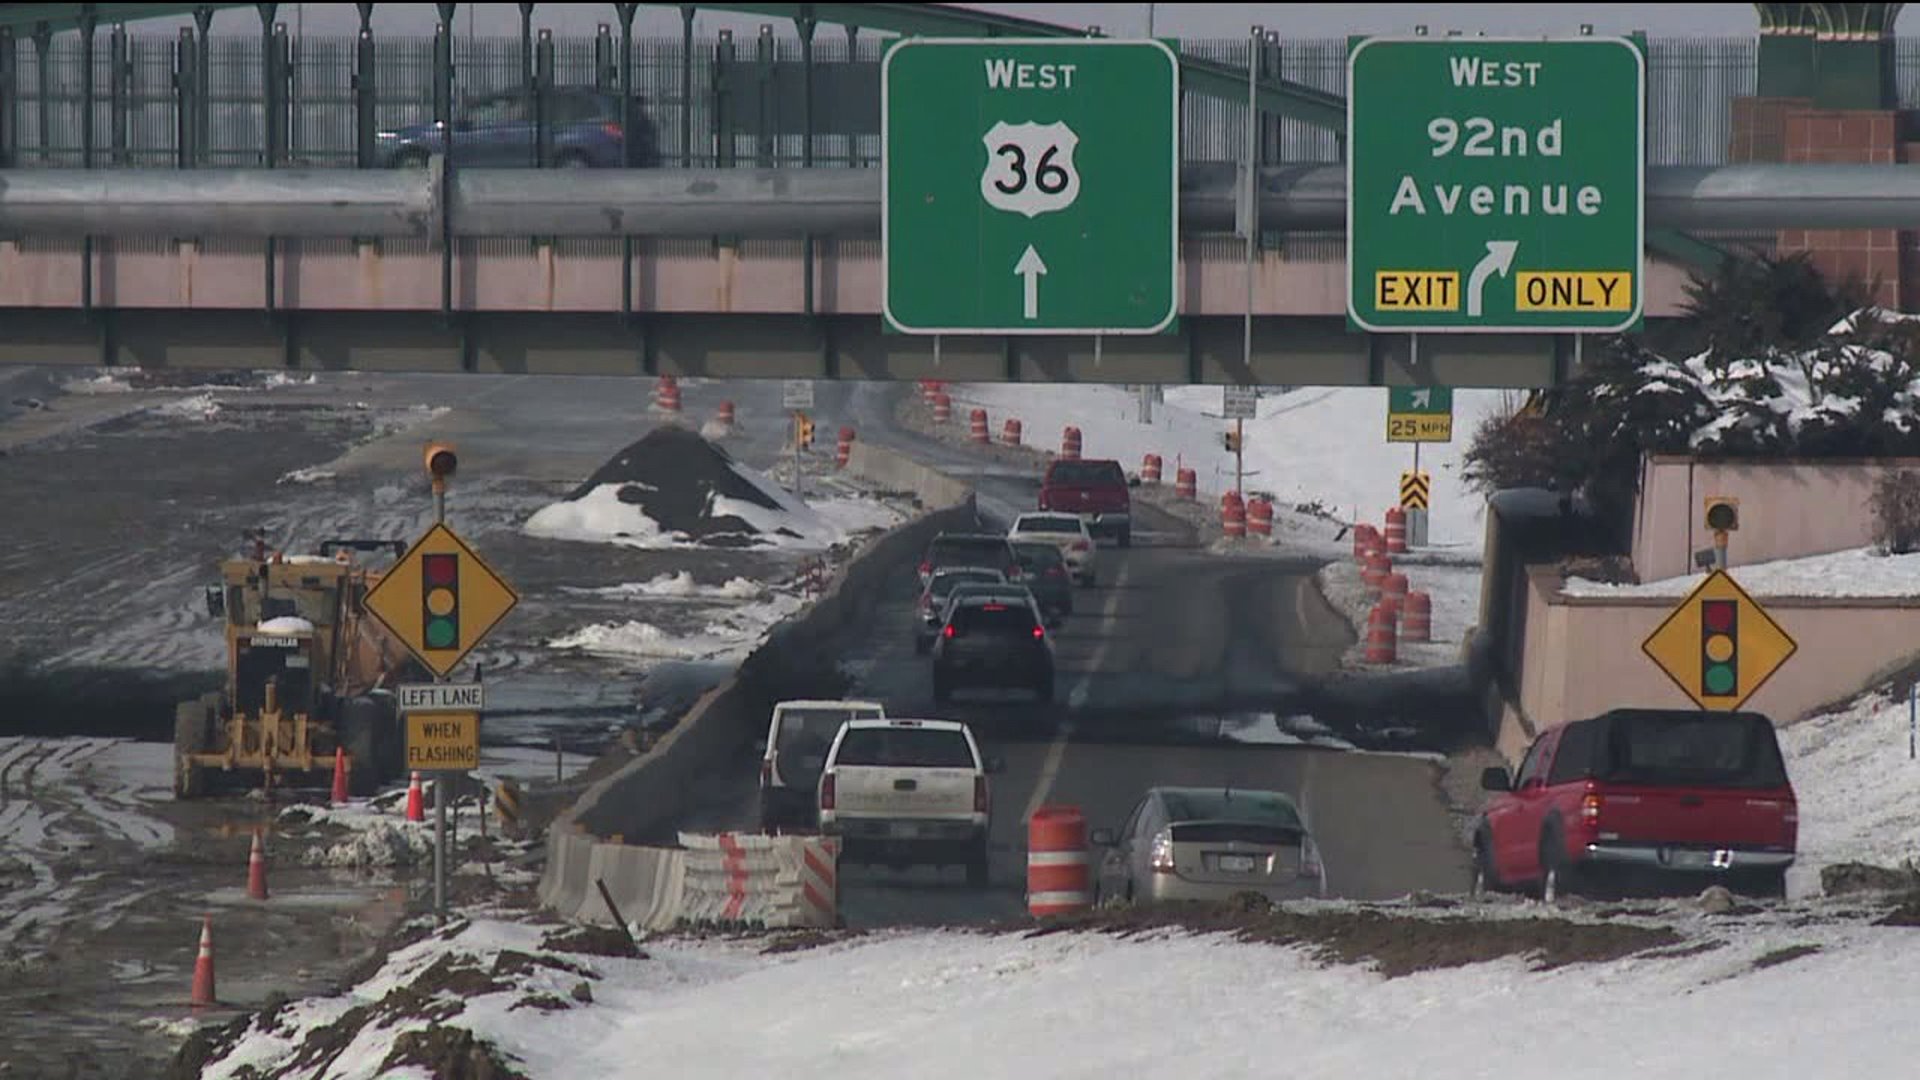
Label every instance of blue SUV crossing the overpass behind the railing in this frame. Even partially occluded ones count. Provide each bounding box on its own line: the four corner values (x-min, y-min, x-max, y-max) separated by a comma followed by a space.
376, 86, 660, 169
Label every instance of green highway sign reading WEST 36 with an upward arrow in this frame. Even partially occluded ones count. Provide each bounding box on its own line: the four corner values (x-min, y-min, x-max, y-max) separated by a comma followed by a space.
879, 38, 1179, 334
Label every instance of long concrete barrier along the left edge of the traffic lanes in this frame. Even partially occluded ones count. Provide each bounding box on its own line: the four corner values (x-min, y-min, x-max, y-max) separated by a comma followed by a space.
540, 442, 979, 924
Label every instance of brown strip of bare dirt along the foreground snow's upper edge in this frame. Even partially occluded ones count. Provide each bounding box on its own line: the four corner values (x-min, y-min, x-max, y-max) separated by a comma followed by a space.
1031, 903, 1682, 978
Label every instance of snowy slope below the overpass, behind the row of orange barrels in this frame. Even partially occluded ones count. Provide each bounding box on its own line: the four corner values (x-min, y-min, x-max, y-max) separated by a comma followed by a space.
948, 382, 1507, 550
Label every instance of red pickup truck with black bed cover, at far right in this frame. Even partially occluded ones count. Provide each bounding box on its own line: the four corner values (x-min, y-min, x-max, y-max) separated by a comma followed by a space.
1473, 709, 1799, 901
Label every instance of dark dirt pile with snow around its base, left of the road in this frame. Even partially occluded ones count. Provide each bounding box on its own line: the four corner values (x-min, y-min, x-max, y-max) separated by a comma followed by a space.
566, 425, 799, 546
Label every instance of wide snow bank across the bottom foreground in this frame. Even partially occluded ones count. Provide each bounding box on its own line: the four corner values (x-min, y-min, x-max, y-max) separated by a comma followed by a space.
191, 905, 1920, 1080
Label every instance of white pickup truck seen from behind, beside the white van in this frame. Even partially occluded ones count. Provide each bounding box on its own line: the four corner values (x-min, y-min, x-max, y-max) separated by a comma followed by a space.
820, 719, 1000, 886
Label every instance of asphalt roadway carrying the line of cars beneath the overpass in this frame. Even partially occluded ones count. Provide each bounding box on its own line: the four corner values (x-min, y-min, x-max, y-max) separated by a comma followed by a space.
684, 384, 1469, 926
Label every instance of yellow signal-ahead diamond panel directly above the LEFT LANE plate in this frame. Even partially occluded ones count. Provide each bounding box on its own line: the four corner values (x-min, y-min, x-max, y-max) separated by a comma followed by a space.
367, 525, 520, 676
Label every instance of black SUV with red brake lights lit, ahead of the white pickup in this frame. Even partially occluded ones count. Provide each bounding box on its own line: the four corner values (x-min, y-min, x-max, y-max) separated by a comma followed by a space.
933, 594, 1054, 701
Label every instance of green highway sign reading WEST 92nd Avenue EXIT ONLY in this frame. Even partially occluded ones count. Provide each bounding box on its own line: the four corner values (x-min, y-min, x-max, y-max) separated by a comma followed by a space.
1346, 37, 1645, 332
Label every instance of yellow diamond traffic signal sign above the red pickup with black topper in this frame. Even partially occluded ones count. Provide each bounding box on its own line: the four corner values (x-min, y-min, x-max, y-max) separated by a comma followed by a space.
1640, 571, 1799, 709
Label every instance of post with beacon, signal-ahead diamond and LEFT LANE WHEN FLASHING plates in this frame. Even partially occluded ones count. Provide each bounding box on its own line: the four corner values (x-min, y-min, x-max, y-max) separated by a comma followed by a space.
365, 444, 520, 922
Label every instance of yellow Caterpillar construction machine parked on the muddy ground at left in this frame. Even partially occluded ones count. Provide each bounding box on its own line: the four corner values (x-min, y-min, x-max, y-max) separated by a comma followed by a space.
173, 530, 424, 799
